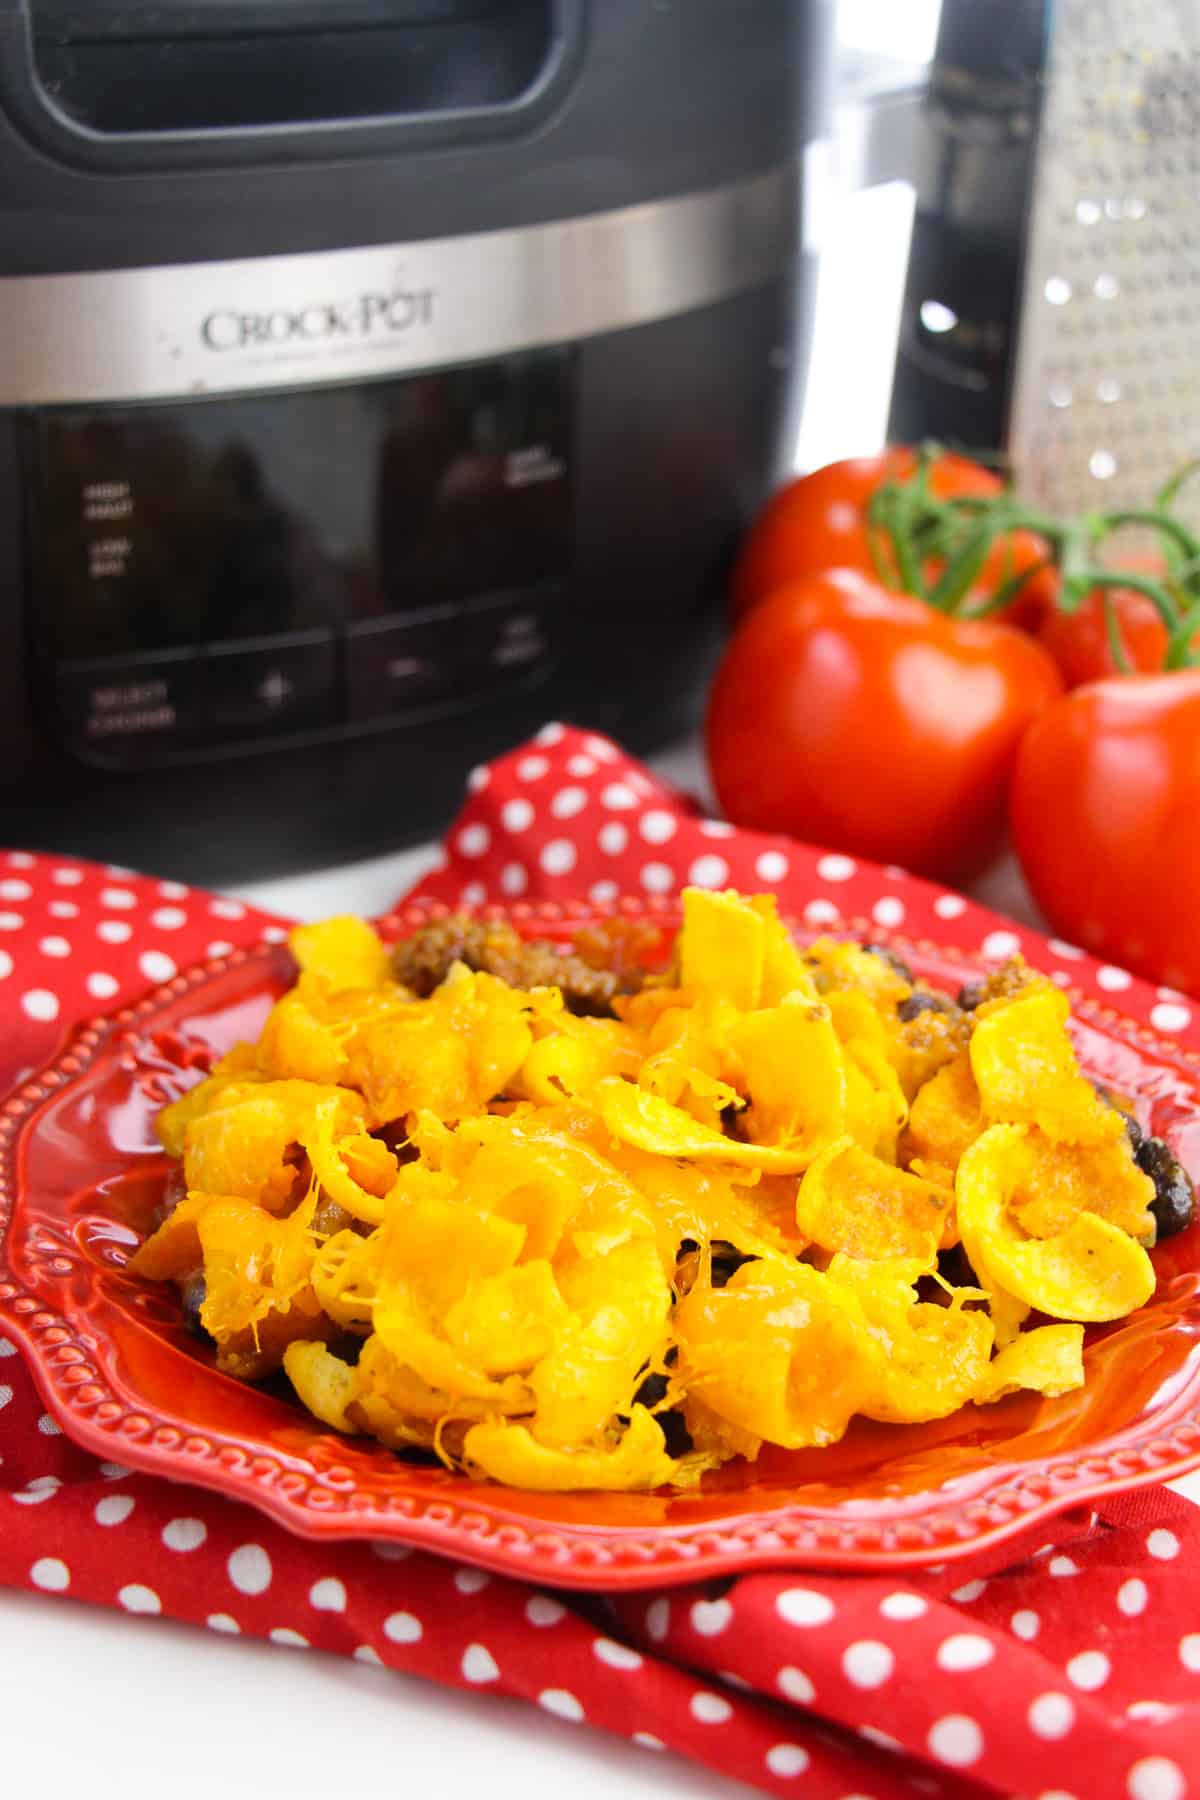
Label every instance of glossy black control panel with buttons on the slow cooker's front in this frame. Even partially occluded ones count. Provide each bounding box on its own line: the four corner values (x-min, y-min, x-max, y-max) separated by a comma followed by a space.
31, 351, 572, 760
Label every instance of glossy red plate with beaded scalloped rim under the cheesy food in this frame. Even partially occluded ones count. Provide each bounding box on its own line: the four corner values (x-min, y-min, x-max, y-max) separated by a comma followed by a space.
0, 902, 1200, 1588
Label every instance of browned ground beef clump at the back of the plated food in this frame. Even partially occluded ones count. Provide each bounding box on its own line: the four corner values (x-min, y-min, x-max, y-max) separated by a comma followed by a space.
392, 913, 642, 1017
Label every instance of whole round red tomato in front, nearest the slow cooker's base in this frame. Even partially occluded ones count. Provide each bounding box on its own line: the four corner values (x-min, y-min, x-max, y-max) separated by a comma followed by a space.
707, 571, 1061, 877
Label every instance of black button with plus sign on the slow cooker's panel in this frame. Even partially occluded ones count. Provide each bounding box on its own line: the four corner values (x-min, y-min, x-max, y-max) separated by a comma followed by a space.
198, 632, 338, 745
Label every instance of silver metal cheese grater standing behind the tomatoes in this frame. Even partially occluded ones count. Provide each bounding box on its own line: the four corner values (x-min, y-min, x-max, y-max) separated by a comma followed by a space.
1007, 0, 1200, 522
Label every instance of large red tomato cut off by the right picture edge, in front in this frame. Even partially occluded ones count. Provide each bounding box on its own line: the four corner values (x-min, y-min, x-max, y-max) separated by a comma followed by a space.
1011, 670, 1200, 994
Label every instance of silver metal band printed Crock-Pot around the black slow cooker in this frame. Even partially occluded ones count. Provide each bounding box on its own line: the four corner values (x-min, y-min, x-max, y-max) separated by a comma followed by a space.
0, 164, 799, 407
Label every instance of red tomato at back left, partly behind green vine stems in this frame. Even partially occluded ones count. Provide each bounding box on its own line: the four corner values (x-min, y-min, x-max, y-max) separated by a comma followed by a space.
732, 446, 1052, 623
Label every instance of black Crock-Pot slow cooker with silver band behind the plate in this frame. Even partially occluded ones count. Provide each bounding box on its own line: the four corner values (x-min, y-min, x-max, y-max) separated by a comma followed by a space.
0, 0, 826, 880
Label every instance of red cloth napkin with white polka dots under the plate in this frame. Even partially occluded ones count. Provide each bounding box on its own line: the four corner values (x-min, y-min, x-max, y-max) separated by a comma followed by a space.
0, 725, 1200, 1800
